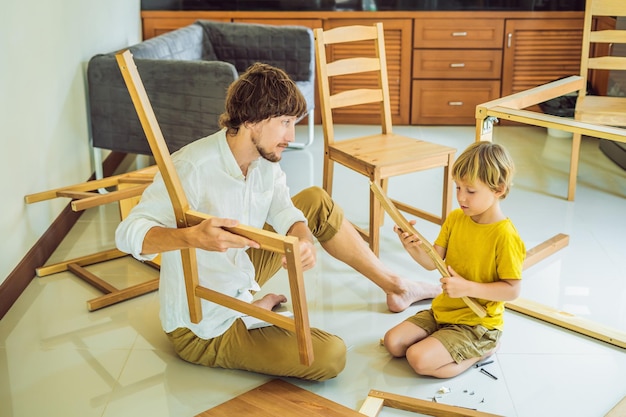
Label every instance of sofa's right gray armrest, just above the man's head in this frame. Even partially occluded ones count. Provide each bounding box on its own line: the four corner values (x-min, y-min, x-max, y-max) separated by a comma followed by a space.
196, 20, 315, 82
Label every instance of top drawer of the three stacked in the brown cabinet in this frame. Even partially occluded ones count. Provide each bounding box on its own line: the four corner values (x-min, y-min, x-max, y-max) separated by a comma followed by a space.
413, 19, 504, 49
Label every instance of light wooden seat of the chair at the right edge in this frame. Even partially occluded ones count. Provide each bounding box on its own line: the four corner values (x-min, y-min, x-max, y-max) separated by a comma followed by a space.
575, 96, 626, 126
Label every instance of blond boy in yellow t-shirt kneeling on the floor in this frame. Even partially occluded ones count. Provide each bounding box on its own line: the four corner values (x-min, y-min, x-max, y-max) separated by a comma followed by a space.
384, 142, 526, 378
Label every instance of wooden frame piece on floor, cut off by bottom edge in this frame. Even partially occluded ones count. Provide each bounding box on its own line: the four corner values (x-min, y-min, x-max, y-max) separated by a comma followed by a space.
359, 390, 499, 417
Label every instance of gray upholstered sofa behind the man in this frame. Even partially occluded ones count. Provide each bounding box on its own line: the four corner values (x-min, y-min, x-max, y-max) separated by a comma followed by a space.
87, 21, 315, 158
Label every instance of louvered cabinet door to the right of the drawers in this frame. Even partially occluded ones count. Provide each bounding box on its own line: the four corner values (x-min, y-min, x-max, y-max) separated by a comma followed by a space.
502, 19, 583, 96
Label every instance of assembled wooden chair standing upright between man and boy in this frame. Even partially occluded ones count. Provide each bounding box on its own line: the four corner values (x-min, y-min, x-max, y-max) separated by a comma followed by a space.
314, 23, 456, 255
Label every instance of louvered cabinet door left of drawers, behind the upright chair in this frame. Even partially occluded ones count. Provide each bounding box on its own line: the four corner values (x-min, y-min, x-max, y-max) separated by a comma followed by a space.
324, 19, 412, 125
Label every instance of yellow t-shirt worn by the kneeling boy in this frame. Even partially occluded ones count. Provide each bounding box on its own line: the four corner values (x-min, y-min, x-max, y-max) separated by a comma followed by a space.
432, 209, 526, 330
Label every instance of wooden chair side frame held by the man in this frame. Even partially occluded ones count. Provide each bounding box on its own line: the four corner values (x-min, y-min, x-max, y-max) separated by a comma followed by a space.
116, 50, 313, 365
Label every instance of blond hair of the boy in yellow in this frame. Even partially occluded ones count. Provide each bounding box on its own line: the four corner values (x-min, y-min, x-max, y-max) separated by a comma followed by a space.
452, 141, 515, 198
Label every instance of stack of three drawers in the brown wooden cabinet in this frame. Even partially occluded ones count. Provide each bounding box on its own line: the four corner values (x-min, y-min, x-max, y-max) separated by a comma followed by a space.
411, 19, 504, 125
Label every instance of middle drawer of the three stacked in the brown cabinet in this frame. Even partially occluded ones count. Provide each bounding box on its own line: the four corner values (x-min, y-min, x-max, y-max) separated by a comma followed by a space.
413, 49, 502, 79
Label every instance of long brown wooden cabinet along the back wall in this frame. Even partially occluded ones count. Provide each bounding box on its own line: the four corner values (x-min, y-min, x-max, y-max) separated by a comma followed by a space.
141, 11, 584, 125
